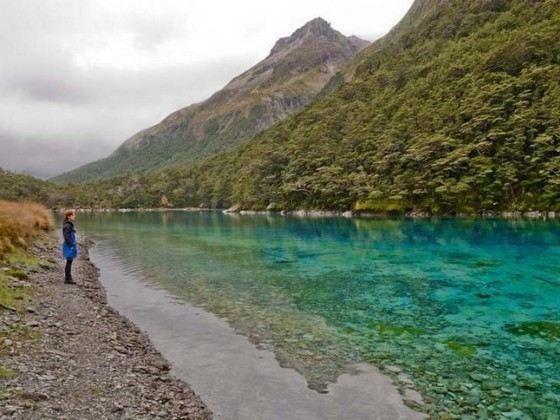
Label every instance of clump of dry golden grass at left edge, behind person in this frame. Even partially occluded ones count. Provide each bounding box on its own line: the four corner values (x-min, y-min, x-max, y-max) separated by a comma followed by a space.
0, 200, 54, 260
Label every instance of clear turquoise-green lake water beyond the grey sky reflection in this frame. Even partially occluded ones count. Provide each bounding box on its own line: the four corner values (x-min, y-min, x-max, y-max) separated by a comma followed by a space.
77, 212, 560, 419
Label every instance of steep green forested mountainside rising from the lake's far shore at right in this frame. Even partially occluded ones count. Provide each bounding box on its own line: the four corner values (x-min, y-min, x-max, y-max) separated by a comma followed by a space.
64, 0, 560, 213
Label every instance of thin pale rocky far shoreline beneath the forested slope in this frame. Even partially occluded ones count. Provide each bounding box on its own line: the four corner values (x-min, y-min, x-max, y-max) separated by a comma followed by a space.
62, 207, 560, 220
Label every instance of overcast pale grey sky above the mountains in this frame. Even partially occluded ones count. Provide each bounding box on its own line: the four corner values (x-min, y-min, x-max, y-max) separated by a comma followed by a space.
0, 0, 412, 178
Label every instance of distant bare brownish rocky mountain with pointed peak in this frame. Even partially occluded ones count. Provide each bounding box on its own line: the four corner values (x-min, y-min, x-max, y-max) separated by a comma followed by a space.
52, 18, 368, 182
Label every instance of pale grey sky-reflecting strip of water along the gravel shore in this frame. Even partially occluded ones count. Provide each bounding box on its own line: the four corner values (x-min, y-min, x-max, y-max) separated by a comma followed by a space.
91, 243, 425, 420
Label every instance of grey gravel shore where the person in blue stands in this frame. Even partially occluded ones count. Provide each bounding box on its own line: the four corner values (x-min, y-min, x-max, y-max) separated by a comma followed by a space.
0, 237, 212, 419
